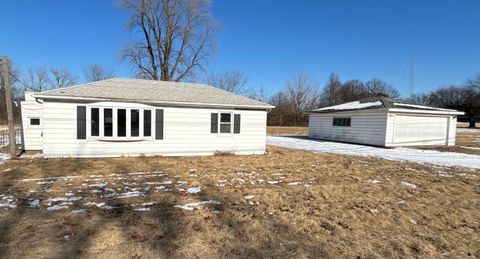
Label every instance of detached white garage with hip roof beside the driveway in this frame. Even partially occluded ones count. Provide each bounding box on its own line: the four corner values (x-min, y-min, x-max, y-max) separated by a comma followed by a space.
308, 97, 463, 147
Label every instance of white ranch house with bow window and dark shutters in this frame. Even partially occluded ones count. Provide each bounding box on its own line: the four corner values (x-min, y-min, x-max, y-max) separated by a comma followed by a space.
21, 78, 273, 158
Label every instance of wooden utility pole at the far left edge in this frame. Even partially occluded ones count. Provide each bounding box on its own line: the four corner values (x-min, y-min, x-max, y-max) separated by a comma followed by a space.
0, 56, 16, 158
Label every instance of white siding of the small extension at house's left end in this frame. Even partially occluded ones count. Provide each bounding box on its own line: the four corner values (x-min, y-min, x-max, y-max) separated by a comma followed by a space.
20, 99, 43, 150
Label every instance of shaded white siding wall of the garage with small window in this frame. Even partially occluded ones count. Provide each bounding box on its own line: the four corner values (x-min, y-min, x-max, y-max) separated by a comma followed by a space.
308, 111, 387, 146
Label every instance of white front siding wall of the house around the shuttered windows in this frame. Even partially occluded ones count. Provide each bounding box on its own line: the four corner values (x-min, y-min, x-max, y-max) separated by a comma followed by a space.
43, 102, 266, 158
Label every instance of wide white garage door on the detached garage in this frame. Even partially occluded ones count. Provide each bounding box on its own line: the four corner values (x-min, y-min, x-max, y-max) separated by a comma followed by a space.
393, 115, 448, 145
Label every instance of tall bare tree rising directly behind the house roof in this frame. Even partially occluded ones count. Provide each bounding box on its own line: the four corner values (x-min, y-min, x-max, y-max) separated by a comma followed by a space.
122, 0, 217, 81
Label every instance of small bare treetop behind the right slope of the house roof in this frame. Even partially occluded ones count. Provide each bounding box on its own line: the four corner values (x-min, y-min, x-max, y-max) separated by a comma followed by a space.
207, 70, 247, 94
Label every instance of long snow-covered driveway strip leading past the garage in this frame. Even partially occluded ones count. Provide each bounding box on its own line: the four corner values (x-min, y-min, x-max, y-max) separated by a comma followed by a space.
267, 136, 480, 169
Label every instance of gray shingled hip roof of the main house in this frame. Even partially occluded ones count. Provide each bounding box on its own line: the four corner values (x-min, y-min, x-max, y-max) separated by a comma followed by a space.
35, 78, 274, 109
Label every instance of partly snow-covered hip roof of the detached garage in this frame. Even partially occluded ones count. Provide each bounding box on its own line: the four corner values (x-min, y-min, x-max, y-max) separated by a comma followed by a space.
310, 97, 457, 113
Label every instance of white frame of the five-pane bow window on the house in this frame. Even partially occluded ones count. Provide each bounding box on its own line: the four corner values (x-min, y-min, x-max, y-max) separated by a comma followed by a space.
87, 105, 155, 141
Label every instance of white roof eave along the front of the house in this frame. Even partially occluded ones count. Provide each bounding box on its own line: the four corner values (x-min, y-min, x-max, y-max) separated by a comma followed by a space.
34, 93, 275, 110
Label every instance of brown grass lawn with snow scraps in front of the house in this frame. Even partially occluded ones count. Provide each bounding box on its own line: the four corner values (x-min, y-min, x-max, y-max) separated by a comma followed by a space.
0, 147, 480, 258
